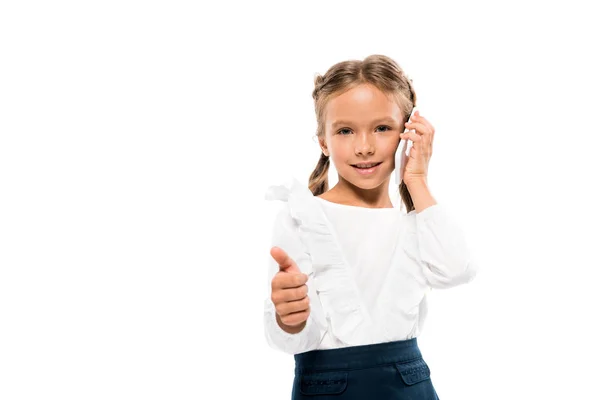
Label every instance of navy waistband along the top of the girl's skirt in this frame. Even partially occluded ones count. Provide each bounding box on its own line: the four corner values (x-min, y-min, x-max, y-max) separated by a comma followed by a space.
294, 337, 423, 374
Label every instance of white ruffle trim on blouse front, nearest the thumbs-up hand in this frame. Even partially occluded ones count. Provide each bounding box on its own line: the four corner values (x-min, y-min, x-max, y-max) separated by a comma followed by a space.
265, 178, 374, 346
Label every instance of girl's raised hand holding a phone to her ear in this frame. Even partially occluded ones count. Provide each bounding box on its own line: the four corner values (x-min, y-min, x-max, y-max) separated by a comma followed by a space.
400, 110, 435, 186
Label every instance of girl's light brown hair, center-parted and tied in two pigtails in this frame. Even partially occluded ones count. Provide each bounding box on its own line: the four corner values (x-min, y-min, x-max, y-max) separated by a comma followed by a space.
308, 54, 417, 216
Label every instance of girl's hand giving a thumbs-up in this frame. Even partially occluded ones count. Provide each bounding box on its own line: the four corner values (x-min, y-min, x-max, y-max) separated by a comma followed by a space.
271, 247, 310, 328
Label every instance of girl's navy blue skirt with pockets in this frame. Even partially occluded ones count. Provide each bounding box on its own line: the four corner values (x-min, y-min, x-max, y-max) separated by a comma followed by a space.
292, 337, 439, 400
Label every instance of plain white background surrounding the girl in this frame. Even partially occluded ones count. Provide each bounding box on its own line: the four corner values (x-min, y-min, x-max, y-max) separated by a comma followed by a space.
0, 1, 600, 400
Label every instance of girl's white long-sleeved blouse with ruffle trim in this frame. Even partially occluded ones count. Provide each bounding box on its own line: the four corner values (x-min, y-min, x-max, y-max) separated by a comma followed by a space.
264, 179, 478, 354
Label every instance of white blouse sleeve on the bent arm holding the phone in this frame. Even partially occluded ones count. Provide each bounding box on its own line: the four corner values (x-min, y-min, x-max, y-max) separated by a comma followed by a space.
416, 204, 479, 289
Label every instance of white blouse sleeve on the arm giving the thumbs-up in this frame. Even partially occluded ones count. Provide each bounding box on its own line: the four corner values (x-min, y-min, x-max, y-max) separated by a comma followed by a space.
264, 203, 324, 354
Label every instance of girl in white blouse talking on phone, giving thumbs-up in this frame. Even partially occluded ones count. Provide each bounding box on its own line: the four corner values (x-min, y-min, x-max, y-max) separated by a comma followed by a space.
264, 55, 477, 400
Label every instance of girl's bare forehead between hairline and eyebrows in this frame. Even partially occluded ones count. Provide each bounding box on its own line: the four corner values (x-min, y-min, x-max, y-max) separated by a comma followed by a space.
325, 84, 401, 124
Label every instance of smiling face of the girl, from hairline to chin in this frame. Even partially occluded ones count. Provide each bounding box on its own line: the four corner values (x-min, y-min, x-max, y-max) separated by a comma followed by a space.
321, 84, 404, 189
